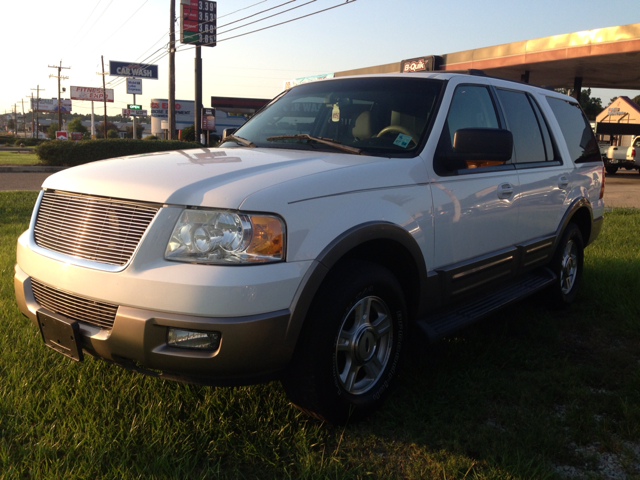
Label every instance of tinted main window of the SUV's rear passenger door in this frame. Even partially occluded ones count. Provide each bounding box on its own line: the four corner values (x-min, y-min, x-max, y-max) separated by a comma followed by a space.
498, 90, 547, 163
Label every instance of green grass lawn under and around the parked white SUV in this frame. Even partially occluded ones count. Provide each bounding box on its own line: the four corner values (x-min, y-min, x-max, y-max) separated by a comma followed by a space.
0, 192, 640, 479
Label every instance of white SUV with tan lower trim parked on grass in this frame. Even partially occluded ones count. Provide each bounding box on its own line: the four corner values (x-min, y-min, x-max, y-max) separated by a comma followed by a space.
15, 73, 604, 423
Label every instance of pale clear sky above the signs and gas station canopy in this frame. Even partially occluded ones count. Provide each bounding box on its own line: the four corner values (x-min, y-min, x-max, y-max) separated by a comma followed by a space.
0, 0, 640, 119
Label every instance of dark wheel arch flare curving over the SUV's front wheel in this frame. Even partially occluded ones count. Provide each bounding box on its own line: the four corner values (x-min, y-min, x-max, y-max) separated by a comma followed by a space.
286, 222, 430, 352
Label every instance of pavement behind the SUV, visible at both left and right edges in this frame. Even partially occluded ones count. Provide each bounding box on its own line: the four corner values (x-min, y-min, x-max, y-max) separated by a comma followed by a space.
0, 165, 640, 208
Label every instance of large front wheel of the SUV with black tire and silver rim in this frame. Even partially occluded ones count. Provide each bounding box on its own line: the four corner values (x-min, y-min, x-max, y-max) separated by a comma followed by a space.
282, 261, 407, 425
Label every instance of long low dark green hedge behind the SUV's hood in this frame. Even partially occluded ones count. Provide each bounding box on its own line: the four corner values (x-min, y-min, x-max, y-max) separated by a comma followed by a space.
35, 139, 202, 166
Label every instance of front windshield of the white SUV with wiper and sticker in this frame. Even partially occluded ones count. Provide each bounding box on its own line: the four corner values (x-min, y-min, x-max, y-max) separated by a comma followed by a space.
224, 77, 444, 156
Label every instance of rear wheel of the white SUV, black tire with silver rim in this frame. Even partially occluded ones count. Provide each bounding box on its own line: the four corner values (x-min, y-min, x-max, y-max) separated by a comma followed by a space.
550, 223, 584, 307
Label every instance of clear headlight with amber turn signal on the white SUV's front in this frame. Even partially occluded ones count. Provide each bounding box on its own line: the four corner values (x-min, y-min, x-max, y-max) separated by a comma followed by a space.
164, 209, 285, 264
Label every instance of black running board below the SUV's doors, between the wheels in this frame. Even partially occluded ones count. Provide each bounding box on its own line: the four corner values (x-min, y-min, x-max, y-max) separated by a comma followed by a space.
417, 268, 557, 341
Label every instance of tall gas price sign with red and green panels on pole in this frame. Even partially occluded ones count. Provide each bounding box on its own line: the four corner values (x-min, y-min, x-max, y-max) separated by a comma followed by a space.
180, 0, 218, 47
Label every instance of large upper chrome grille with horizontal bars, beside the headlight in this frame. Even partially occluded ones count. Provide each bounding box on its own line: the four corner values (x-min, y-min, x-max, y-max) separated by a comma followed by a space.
34, 192, 158, 266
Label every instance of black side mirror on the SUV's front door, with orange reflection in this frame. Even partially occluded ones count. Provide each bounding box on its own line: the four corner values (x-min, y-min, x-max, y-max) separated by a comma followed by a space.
453, 128, 513, 167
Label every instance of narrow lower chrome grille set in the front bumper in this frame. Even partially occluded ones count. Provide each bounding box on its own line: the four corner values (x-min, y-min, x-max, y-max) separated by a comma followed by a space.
31, 278, 118, 328
